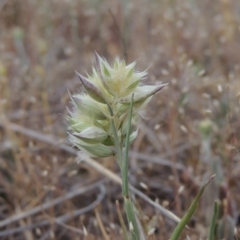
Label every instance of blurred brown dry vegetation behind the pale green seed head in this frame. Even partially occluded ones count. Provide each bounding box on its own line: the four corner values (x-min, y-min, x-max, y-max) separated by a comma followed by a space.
0, 0, 240, 240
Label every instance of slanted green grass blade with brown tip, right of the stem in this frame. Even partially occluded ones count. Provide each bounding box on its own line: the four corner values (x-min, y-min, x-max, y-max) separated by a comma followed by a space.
170, 175, 215, 240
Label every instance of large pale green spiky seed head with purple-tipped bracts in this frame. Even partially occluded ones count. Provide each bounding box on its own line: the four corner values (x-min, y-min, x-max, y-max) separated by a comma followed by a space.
67, 54, 167, 157
